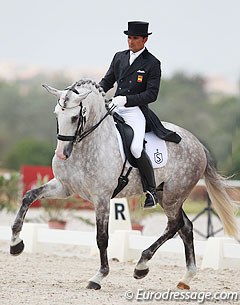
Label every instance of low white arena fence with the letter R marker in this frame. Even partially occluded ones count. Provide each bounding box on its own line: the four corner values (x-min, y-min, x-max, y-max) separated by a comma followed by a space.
0, 198, 240, 269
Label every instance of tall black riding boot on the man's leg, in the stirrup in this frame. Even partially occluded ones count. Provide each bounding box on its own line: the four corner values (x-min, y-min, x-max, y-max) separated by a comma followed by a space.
136, 149, 158, 208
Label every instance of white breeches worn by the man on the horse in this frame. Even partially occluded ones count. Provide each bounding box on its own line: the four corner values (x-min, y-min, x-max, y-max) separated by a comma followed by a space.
115, 106, 146, 159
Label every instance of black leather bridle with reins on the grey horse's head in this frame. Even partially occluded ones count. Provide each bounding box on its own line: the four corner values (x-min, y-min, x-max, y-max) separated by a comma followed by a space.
57, 84, 111, 144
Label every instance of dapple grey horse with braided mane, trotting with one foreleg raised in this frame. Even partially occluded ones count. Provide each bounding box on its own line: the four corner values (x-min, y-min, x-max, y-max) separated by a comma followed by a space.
10, 80, 239, 290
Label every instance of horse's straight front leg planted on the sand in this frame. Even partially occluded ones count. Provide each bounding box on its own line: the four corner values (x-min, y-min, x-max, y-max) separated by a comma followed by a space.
87, 200, 110, 290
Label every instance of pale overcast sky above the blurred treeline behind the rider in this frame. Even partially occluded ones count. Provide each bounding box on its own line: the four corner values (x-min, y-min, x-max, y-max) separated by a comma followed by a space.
0, 0, 240, 81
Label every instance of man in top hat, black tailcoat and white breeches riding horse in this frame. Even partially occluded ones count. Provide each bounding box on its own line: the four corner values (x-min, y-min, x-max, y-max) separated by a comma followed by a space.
99, 21, 180, 208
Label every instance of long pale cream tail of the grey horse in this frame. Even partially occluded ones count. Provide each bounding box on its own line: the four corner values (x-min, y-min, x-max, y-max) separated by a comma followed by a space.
204, 147, 240, 237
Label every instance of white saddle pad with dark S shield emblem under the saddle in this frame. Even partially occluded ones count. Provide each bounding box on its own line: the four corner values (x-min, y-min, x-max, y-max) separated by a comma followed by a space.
116, 129, 168, 168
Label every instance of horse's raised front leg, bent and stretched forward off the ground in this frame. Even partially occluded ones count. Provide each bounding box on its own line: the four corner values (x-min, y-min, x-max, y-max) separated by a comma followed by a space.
10, 178, 71, 255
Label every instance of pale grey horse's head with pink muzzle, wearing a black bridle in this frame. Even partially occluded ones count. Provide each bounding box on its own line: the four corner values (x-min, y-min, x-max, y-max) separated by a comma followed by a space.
43, 83, 92, 160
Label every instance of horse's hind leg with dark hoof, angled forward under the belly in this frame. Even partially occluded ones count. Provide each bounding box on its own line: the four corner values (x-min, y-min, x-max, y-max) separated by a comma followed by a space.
133, 210, 184, 279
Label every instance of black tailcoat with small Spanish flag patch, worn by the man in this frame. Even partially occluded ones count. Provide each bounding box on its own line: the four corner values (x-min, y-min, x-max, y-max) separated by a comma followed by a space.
100, 49, 181, 143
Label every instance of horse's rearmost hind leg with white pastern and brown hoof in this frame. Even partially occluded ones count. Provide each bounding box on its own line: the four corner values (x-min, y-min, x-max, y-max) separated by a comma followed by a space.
177, 211, 196, 289
